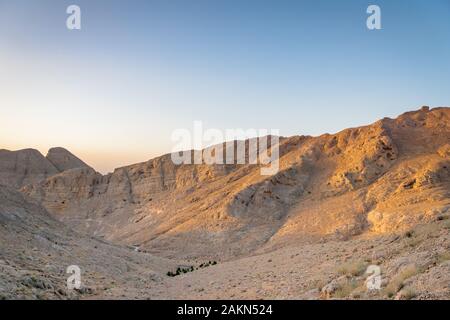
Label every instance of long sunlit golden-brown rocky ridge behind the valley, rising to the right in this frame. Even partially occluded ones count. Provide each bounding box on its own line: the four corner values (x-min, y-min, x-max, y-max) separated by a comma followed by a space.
22, 108, 450, 257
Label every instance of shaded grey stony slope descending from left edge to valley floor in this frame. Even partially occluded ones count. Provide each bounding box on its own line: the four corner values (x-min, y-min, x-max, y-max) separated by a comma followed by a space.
0, 186, 175, 300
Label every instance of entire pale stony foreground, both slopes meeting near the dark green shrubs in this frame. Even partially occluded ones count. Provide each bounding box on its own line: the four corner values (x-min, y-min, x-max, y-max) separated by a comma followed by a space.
0, 182, 450, 299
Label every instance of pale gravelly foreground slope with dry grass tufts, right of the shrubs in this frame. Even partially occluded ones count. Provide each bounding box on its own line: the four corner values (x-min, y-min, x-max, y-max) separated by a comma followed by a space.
154, 218, 450, 300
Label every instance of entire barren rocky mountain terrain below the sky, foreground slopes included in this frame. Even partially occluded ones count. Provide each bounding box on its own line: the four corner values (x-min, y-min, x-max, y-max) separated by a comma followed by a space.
0, 107, 450, 300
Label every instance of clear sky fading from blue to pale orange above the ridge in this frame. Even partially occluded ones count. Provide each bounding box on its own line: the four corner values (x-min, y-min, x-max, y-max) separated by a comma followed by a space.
0, 0, 450, 171
